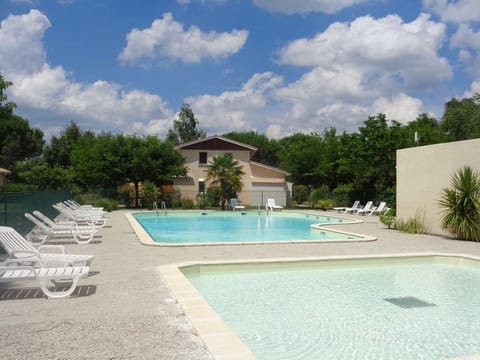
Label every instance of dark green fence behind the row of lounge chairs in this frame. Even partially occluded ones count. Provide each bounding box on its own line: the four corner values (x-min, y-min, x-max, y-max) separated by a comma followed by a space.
0, 190, 71, 235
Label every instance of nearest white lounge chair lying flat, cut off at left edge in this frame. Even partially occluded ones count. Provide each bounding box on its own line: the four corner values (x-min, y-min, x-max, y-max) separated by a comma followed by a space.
0, 260, 90, 299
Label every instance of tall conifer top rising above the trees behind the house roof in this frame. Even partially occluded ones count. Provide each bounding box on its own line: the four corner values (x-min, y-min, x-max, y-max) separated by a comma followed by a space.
167, 103, 205, 145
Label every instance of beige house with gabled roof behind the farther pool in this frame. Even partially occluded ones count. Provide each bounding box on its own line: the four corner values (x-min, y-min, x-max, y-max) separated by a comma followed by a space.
173, 135, 292, 207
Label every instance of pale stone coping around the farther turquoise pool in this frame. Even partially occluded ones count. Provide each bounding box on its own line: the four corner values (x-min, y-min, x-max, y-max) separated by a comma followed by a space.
125, 211, 377, 247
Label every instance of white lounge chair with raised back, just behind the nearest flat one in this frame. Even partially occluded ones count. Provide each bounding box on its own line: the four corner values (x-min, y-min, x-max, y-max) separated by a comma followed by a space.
0, 226, 95, 267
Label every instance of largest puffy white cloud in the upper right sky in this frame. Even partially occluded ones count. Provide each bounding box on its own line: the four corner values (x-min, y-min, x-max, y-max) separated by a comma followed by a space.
279, 14, 452, 88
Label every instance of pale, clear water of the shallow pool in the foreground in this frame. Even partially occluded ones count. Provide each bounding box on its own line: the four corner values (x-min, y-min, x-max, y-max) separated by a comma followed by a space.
182, 257, 480, 360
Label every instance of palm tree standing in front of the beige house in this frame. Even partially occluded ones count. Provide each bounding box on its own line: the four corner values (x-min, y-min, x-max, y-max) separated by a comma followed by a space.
207, 153, 245, 210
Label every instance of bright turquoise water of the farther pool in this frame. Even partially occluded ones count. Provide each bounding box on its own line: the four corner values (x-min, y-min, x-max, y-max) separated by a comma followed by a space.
134, 211, 355, 244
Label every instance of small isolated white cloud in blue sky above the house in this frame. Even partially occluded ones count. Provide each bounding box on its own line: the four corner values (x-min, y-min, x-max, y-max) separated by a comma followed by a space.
119, 13, 248, 64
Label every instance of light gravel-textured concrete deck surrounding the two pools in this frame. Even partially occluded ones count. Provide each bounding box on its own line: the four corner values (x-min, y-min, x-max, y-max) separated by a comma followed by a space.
0, 210, 480, 360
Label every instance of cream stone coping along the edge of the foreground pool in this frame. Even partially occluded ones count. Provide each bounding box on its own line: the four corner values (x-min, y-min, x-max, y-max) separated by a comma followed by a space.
157, 252, 480, 360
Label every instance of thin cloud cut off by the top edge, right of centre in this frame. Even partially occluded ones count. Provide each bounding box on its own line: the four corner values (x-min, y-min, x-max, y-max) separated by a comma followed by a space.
253, 0, 371, 14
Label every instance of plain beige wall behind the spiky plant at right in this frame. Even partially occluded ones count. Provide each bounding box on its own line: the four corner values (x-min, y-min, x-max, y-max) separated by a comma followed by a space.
397, 139, 480, 234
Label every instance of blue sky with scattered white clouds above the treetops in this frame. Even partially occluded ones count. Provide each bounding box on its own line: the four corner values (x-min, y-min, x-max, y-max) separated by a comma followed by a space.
0, 0, 480, 141
